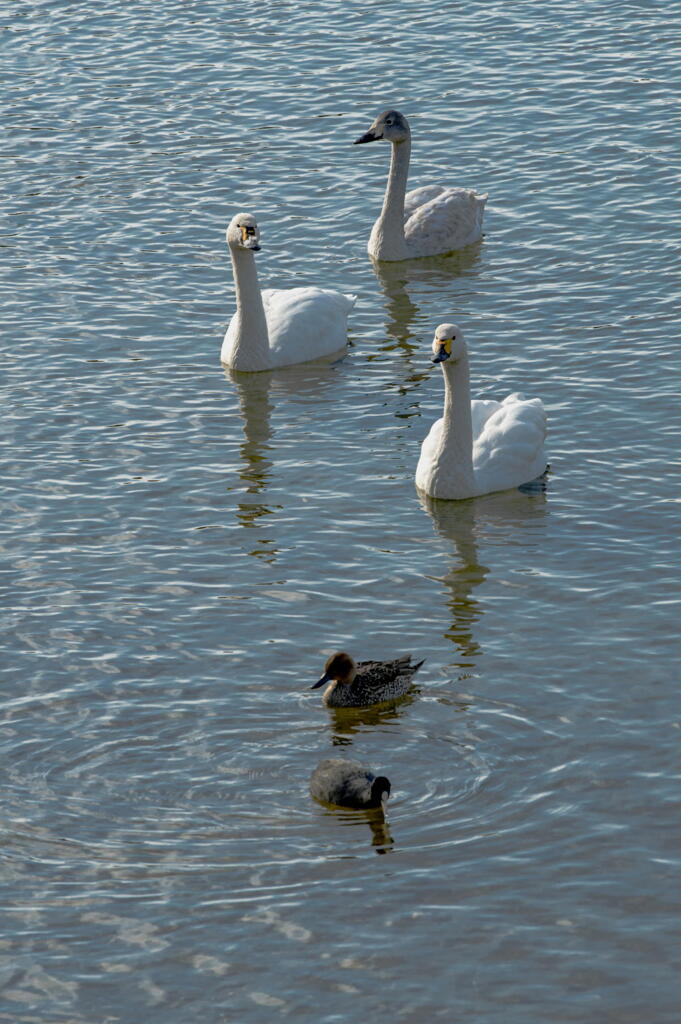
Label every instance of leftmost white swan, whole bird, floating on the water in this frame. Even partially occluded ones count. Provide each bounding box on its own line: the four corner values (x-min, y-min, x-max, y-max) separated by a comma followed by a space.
220, 213, 356, 371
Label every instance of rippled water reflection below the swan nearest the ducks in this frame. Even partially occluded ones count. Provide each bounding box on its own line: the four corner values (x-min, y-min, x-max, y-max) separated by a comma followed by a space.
419, 489, 548, 668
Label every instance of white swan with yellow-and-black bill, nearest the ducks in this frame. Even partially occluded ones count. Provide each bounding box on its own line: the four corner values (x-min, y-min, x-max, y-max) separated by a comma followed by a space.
416, 324, 546, 499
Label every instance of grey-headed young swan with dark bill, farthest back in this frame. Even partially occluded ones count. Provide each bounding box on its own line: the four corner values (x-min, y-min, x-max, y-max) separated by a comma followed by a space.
354, 111, 487, 260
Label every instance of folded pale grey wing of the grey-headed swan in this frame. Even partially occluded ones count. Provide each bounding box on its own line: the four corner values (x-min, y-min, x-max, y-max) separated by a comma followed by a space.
405, 188, 487, 256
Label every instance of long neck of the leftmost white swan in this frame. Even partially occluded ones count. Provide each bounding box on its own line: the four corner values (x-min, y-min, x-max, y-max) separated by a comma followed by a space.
229, 246, 269, 370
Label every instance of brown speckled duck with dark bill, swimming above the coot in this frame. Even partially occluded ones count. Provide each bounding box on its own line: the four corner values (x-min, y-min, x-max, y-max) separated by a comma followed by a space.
310, 651, 425, 708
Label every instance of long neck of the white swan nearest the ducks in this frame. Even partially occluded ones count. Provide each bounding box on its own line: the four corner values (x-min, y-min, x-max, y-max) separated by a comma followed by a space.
435, 354, 475, 496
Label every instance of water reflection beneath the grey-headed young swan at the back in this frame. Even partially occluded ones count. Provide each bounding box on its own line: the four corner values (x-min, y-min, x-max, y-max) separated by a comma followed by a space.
372, 245, 480, 351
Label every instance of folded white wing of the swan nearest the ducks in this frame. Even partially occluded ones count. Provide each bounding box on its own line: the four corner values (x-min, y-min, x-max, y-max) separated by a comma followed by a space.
473, 394, 546, 490
